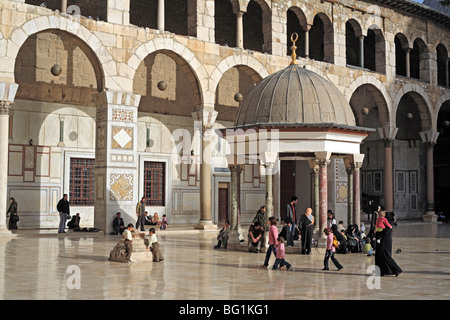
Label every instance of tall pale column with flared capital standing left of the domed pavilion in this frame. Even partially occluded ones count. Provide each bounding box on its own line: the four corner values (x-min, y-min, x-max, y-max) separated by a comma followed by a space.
192, 110, 217, 230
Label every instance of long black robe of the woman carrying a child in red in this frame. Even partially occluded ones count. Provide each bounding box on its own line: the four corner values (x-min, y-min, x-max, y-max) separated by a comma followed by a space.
375, 222, 402, 277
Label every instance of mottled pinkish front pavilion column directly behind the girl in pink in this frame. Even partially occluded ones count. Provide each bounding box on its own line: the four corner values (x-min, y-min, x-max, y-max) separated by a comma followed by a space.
315, 152, 331, 236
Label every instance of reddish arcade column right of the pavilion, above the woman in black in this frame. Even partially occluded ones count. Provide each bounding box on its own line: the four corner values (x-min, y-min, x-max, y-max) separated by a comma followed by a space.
378, 127, 398, 212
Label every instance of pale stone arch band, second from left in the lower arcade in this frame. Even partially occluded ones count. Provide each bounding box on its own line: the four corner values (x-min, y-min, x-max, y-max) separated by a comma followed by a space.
127, 38, 210, 106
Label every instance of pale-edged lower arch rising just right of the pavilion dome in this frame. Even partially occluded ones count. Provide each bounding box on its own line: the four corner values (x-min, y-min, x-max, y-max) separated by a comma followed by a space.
344, 76, 392, 127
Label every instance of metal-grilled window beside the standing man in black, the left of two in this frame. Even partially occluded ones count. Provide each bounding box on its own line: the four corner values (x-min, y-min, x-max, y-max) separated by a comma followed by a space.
69, 158, 95, 206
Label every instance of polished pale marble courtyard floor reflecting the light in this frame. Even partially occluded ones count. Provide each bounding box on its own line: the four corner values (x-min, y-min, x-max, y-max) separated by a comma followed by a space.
0, 221, 450, 300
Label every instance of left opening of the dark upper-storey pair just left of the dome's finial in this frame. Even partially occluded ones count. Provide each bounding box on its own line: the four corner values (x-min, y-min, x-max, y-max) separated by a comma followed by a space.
214, 0, 236, 47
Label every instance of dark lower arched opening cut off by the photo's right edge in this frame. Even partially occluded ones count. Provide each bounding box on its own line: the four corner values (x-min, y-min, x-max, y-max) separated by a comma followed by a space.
433, 100, 450, 217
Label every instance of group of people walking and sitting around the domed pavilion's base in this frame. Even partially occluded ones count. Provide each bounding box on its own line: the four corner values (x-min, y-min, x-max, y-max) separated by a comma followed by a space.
214, 196, 402, 276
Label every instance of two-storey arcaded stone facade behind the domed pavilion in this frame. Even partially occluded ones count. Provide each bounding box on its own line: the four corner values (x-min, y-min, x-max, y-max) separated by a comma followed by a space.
0, 0, 450, 228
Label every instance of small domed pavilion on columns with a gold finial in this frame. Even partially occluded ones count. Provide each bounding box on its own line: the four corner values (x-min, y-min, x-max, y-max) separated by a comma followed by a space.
222, 35, 374, 244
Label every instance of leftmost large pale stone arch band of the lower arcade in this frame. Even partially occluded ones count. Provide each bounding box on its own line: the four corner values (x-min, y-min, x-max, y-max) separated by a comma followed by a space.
6, 15, 114, 91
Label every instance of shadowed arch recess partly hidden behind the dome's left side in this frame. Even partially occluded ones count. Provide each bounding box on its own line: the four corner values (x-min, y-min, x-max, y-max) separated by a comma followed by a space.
214, 65, 261, 125
